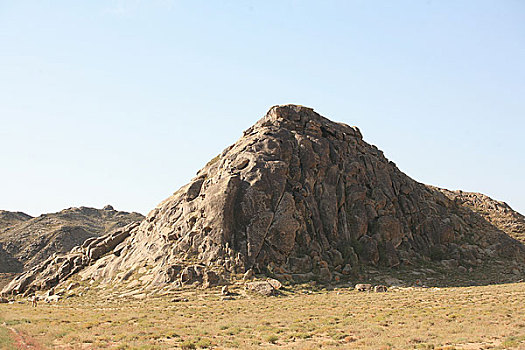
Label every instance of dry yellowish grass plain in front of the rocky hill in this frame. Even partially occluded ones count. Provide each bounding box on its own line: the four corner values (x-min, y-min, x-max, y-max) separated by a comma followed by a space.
0, 283, 525, 349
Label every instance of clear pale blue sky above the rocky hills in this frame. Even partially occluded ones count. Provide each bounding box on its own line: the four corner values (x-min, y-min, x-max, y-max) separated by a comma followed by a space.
0, 0, 525, 215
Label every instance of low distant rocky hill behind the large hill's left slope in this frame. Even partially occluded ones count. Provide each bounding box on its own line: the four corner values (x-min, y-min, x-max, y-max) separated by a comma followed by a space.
0, 206, 144, 273
